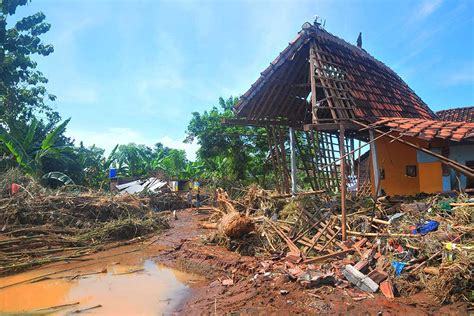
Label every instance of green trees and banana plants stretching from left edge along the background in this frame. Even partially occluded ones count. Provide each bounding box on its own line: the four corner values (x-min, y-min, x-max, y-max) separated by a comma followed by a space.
0, 0, 201, 188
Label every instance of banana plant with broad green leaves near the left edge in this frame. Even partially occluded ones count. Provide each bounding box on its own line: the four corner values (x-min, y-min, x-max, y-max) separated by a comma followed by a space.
0, 118, 74, 184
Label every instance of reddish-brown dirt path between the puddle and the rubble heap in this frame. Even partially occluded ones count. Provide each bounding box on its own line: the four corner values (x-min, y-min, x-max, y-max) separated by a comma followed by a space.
154, 210, 468, 315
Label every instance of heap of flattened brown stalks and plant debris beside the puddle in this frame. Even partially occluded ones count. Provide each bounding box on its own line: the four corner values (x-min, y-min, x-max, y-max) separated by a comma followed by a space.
0, 172, 174, 275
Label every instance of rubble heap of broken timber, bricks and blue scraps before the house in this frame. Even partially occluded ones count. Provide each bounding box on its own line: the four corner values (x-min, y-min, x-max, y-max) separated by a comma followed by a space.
205, 188, 474, 303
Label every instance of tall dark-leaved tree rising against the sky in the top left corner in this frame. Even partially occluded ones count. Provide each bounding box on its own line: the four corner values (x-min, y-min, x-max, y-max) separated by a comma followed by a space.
0, 0, 60, 126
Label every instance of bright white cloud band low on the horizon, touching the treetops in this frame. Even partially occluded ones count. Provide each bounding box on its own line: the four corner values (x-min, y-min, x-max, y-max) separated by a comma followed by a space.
66, 127, 199, 160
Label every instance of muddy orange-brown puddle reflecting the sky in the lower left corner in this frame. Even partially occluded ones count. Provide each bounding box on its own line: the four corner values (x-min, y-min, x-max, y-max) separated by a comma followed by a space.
0, 253, 203, 315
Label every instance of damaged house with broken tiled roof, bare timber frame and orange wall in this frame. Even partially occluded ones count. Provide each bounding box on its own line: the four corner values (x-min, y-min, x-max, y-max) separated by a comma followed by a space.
225, 22, 474, 196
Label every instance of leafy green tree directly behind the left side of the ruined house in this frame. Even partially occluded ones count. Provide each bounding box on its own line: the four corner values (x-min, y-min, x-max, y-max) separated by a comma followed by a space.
186, 97, 271, 187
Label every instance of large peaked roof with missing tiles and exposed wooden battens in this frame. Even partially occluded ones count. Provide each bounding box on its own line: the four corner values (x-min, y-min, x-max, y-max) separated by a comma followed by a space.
235, 23, 436, 126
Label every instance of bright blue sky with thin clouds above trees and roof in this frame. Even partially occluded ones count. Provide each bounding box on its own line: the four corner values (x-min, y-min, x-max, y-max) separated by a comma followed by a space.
12, 0, 474, 159
